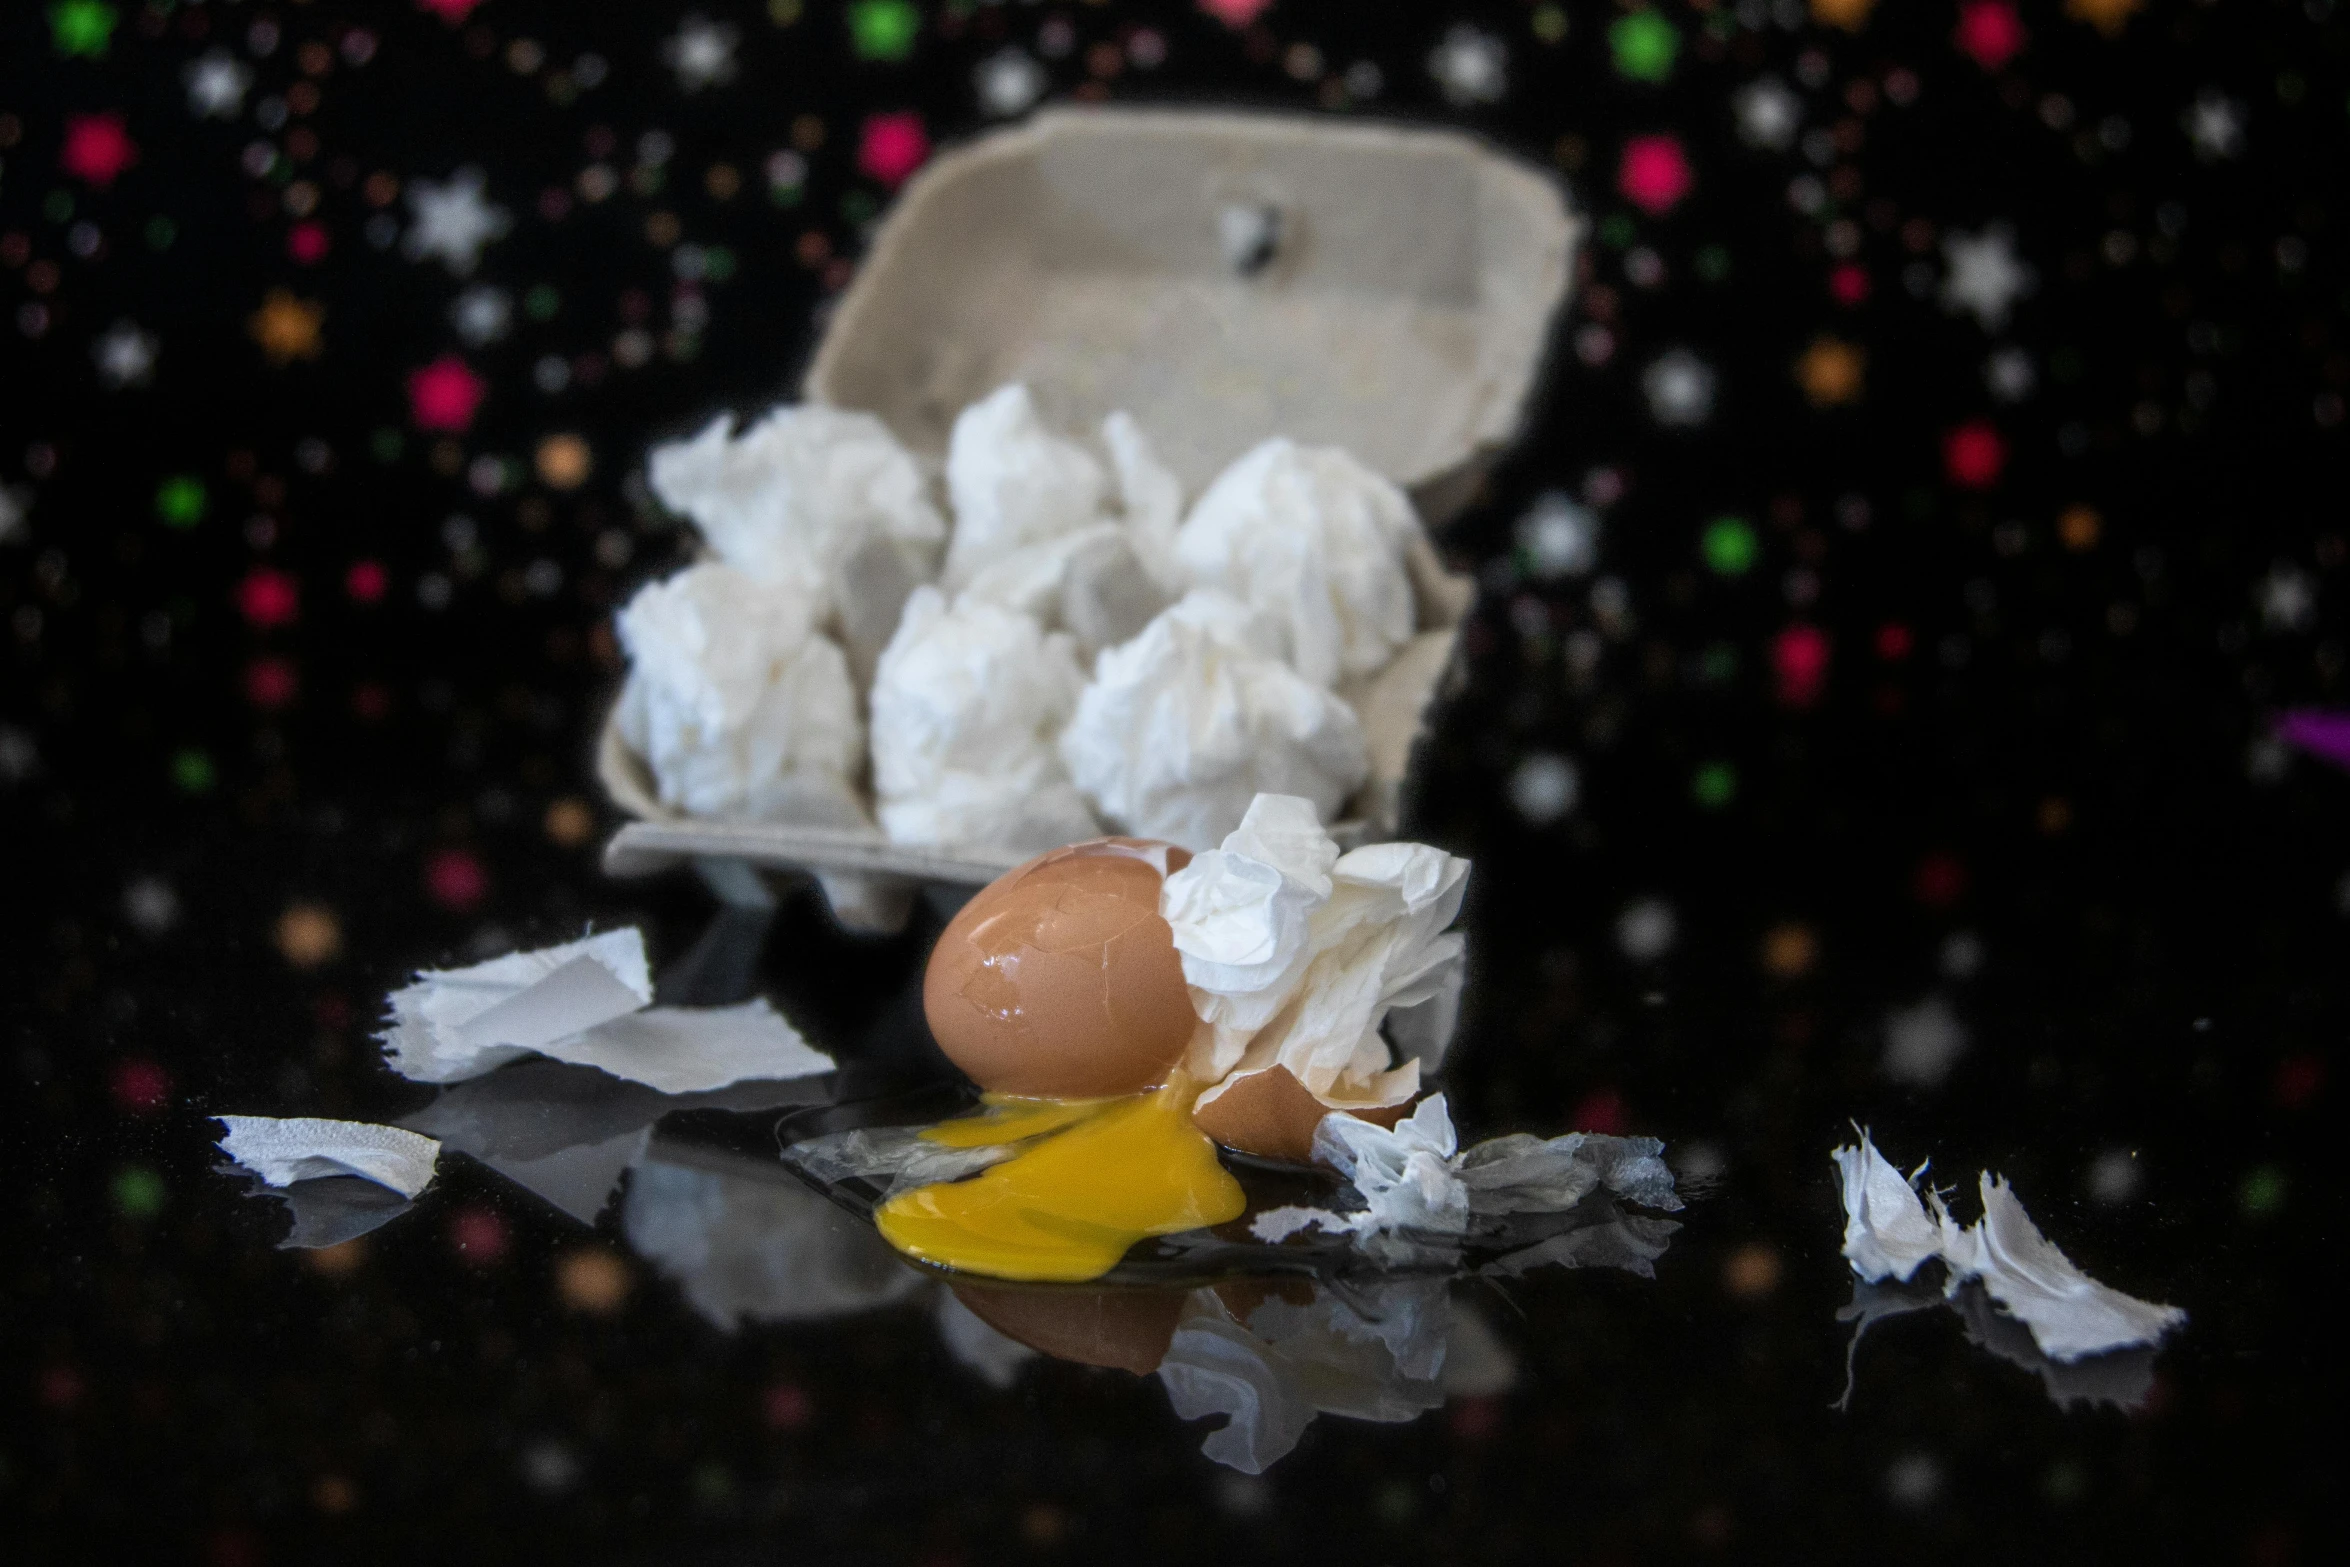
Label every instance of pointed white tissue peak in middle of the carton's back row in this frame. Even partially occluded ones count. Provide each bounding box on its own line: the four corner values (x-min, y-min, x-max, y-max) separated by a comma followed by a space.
945, 381, 1107, 587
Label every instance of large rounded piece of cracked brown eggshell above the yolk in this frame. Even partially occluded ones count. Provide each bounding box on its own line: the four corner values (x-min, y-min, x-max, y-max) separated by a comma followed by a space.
921, 839, 1199, 1099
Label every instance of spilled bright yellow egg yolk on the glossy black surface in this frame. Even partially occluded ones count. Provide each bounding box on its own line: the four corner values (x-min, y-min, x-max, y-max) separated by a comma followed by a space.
874, 1076, 1248, 1283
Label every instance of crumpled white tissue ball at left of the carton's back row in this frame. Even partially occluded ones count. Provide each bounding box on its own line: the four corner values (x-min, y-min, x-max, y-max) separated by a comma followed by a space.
646, 404, 947, 611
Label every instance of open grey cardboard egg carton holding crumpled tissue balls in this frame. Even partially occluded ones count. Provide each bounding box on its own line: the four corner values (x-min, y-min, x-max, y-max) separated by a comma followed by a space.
597, 108, 1584, 930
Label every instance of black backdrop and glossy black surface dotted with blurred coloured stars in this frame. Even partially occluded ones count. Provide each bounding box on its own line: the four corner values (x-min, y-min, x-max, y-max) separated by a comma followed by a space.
0, 0, 2350, 1567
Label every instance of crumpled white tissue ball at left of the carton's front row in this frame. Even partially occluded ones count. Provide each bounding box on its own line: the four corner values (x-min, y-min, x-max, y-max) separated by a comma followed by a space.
618, 561, 867, 827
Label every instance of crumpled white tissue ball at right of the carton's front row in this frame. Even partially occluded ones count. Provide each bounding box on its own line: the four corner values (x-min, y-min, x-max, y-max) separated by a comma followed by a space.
1060, 592, 1370, 850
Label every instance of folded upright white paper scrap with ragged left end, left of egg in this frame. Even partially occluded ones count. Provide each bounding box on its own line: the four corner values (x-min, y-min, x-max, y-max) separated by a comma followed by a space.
376, 928, 653, 1083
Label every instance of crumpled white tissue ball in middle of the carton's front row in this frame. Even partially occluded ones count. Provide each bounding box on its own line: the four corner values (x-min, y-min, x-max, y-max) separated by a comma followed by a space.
872, 587, 1100, 850
